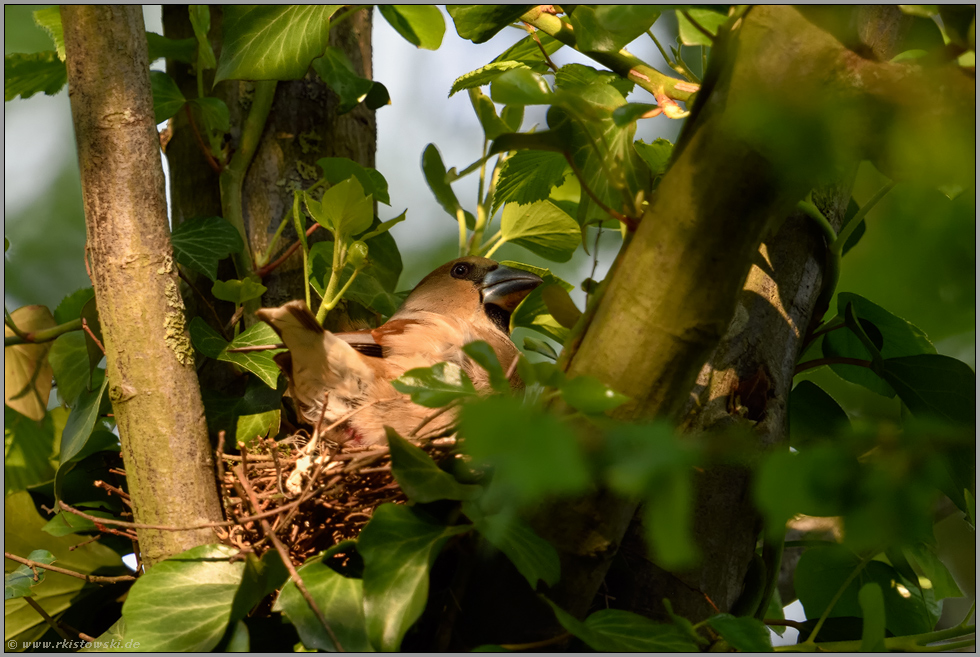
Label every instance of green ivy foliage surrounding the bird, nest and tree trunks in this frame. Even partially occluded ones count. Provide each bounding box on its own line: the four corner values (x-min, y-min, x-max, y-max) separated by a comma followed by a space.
4, 5, 976, 652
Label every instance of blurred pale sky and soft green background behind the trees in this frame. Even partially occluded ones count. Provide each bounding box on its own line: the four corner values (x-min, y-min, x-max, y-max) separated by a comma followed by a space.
4, 5, 976, 419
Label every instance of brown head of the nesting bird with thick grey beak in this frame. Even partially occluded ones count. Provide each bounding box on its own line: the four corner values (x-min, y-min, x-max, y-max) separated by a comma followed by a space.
397, 256, 543, 333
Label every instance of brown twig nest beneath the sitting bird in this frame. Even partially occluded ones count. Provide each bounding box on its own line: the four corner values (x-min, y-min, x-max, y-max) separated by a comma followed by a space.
217, 432, 456, 565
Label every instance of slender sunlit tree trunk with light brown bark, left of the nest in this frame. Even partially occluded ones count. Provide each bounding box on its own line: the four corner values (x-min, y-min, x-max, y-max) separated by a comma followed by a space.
61, 5, 221, 565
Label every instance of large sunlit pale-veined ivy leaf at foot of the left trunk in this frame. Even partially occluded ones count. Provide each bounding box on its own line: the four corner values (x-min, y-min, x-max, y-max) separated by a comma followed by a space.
123, 545, 245, 652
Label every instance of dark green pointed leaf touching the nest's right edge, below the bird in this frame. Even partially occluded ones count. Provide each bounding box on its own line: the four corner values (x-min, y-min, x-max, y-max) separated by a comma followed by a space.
385, 427, 480, 504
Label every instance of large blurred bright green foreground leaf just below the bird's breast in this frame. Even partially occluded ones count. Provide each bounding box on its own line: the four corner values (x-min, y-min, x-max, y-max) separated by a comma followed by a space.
459, 397, 590, 505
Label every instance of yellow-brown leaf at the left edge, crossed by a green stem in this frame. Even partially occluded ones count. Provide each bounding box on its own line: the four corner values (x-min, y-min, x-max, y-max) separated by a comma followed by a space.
3, 306, 55, 421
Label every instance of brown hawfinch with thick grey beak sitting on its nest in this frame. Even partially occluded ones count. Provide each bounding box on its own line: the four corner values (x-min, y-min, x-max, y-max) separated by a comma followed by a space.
255, 256, 542, 445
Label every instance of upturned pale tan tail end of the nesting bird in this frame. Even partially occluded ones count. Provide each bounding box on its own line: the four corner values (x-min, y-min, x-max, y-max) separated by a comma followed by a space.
255, 301, 376, 424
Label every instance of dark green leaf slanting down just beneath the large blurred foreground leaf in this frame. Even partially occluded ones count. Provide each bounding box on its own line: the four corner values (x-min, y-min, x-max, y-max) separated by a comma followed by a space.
463, 503, 561, 589
